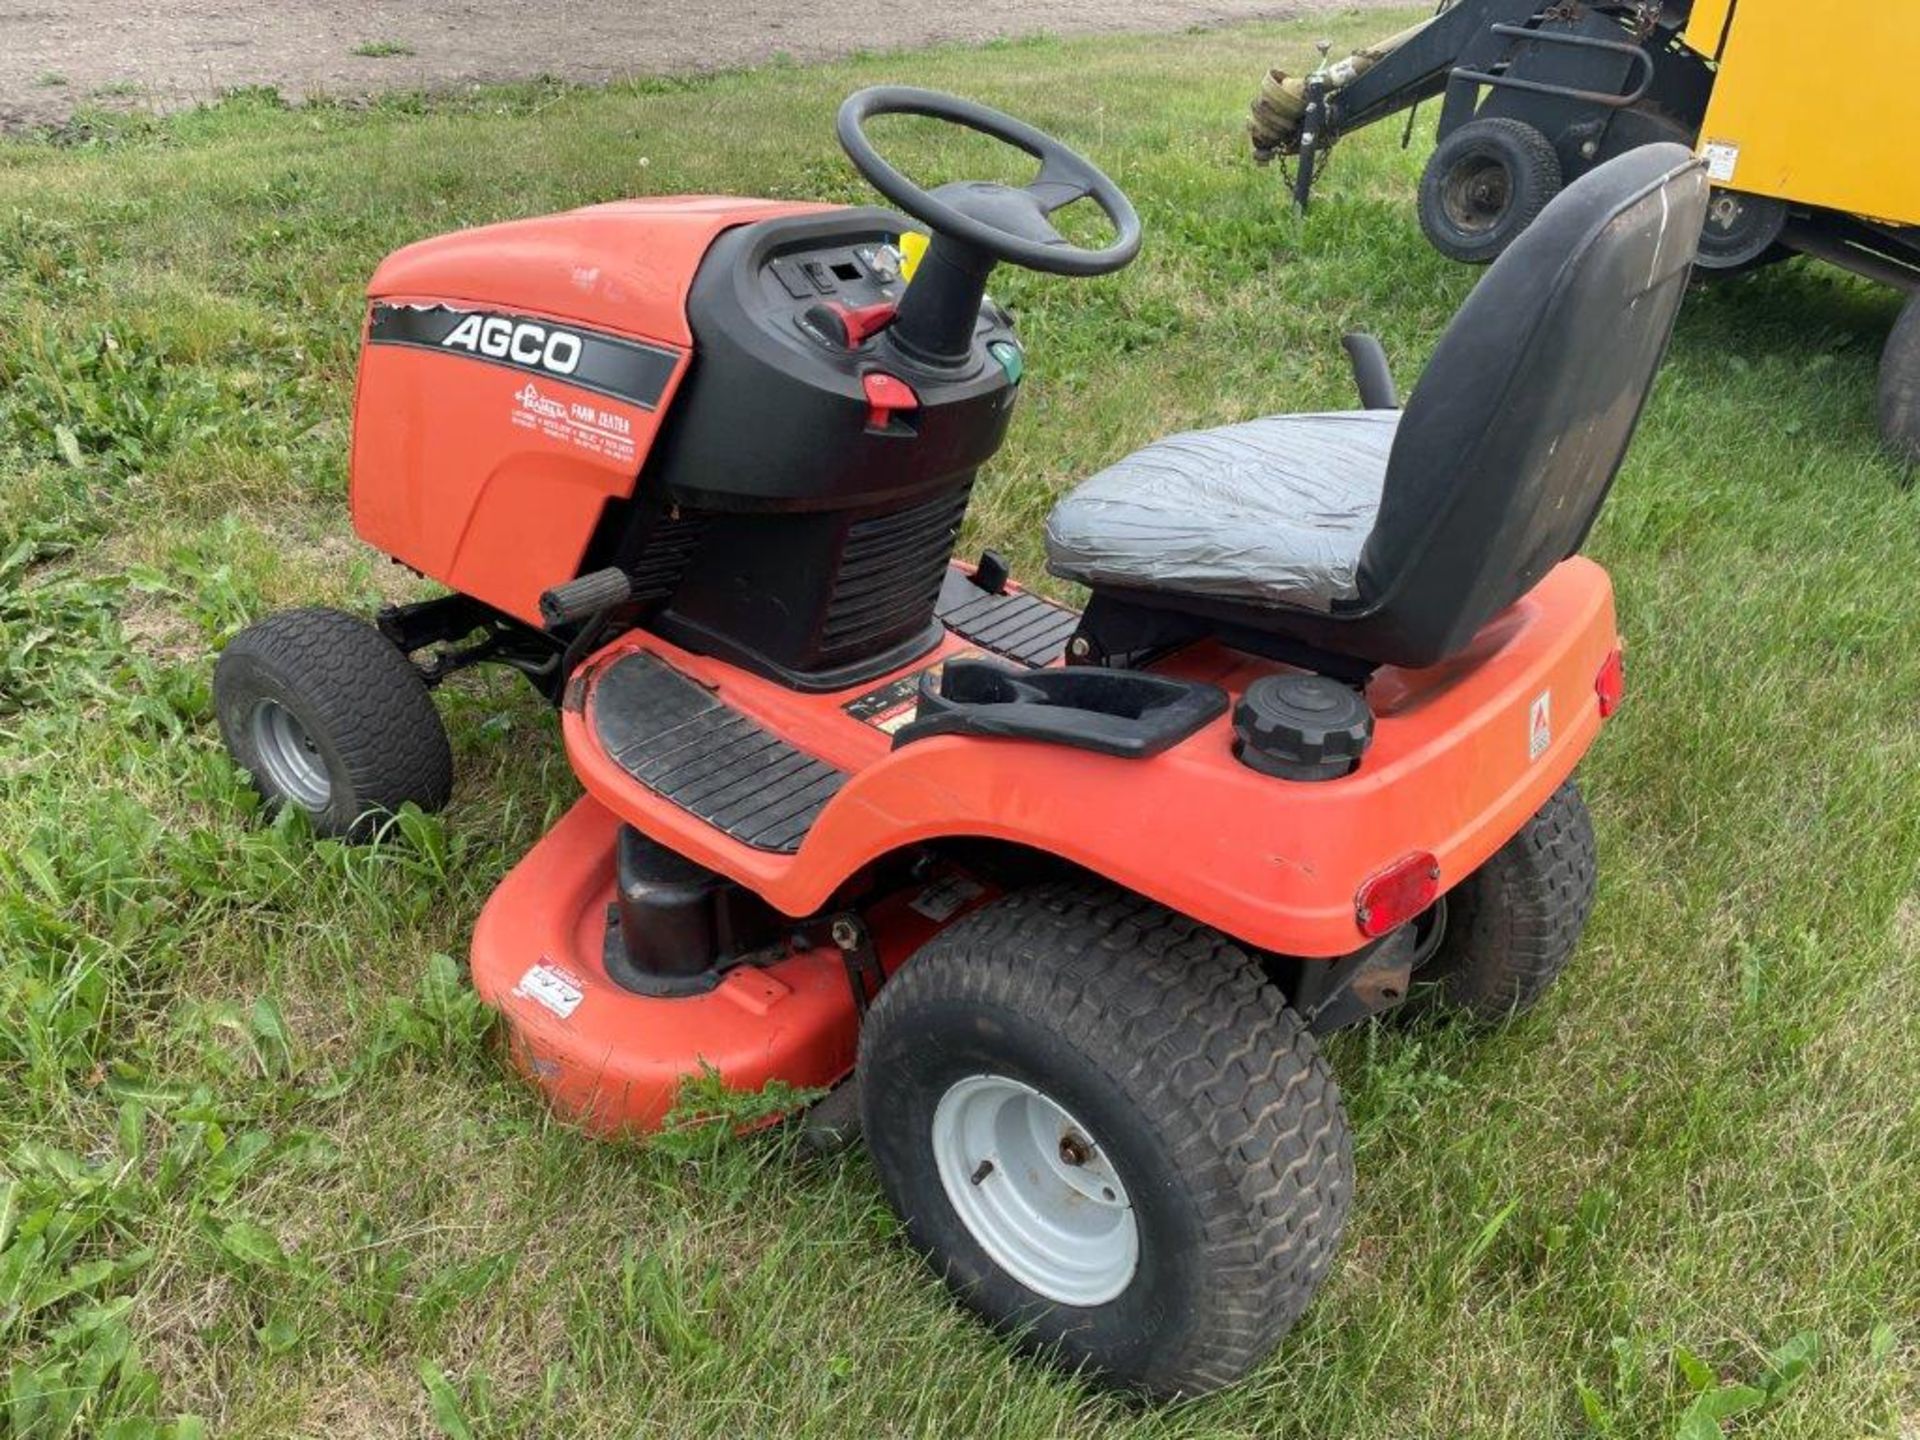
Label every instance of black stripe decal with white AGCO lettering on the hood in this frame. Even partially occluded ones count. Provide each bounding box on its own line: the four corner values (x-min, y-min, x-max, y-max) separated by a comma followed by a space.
367, 301, 680, 411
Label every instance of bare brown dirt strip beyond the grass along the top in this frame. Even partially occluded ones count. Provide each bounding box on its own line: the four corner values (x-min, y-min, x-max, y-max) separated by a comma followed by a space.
0, 0, 1386, 129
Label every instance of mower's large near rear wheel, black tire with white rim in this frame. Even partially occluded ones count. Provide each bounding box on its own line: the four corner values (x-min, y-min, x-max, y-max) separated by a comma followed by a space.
858, 883, 1352, 1396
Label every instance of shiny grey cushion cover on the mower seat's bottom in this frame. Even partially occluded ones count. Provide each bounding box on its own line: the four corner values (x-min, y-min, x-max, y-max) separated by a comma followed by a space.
1046, 411, 1400, 611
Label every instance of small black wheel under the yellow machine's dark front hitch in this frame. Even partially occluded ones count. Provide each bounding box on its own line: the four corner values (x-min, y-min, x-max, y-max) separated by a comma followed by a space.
1419, 117, 1561, 265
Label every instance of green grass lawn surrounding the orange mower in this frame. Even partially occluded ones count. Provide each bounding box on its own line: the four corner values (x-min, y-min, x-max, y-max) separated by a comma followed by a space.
0, 15, 1920, 1440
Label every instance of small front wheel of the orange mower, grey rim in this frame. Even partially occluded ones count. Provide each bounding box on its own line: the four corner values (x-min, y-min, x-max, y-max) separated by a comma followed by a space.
213, 609, 453, 841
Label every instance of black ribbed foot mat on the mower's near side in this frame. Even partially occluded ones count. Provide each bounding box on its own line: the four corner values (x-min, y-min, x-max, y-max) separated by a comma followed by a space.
591, 653, 847, 854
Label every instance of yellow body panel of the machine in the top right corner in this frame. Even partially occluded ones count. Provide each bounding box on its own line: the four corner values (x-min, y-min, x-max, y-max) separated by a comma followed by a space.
1686, 0, 1920, 225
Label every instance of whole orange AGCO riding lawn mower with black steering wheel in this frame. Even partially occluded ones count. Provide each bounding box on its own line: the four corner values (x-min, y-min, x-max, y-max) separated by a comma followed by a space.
215, 86, 1709, 1396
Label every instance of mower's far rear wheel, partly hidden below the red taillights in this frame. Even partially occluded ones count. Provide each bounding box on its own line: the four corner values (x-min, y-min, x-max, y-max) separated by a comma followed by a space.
1413, 780, 1597, 1021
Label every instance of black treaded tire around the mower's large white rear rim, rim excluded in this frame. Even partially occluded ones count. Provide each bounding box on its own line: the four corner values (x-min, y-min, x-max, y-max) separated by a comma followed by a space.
860, 881, 1354, 1396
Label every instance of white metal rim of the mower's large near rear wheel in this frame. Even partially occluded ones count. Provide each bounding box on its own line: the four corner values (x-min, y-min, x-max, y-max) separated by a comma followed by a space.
933, 1075, 1140, 1306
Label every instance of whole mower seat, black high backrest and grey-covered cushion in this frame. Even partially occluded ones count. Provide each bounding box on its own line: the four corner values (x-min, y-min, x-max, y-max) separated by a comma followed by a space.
1046, 144, 1707, 674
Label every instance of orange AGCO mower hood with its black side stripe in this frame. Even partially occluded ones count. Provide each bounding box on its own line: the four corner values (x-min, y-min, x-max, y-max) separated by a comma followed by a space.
351, 196, 835, 624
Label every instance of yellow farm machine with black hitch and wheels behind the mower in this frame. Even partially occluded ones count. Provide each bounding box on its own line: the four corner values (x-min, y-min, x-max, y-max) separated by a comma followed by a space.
1250, 0, 1920, 461
